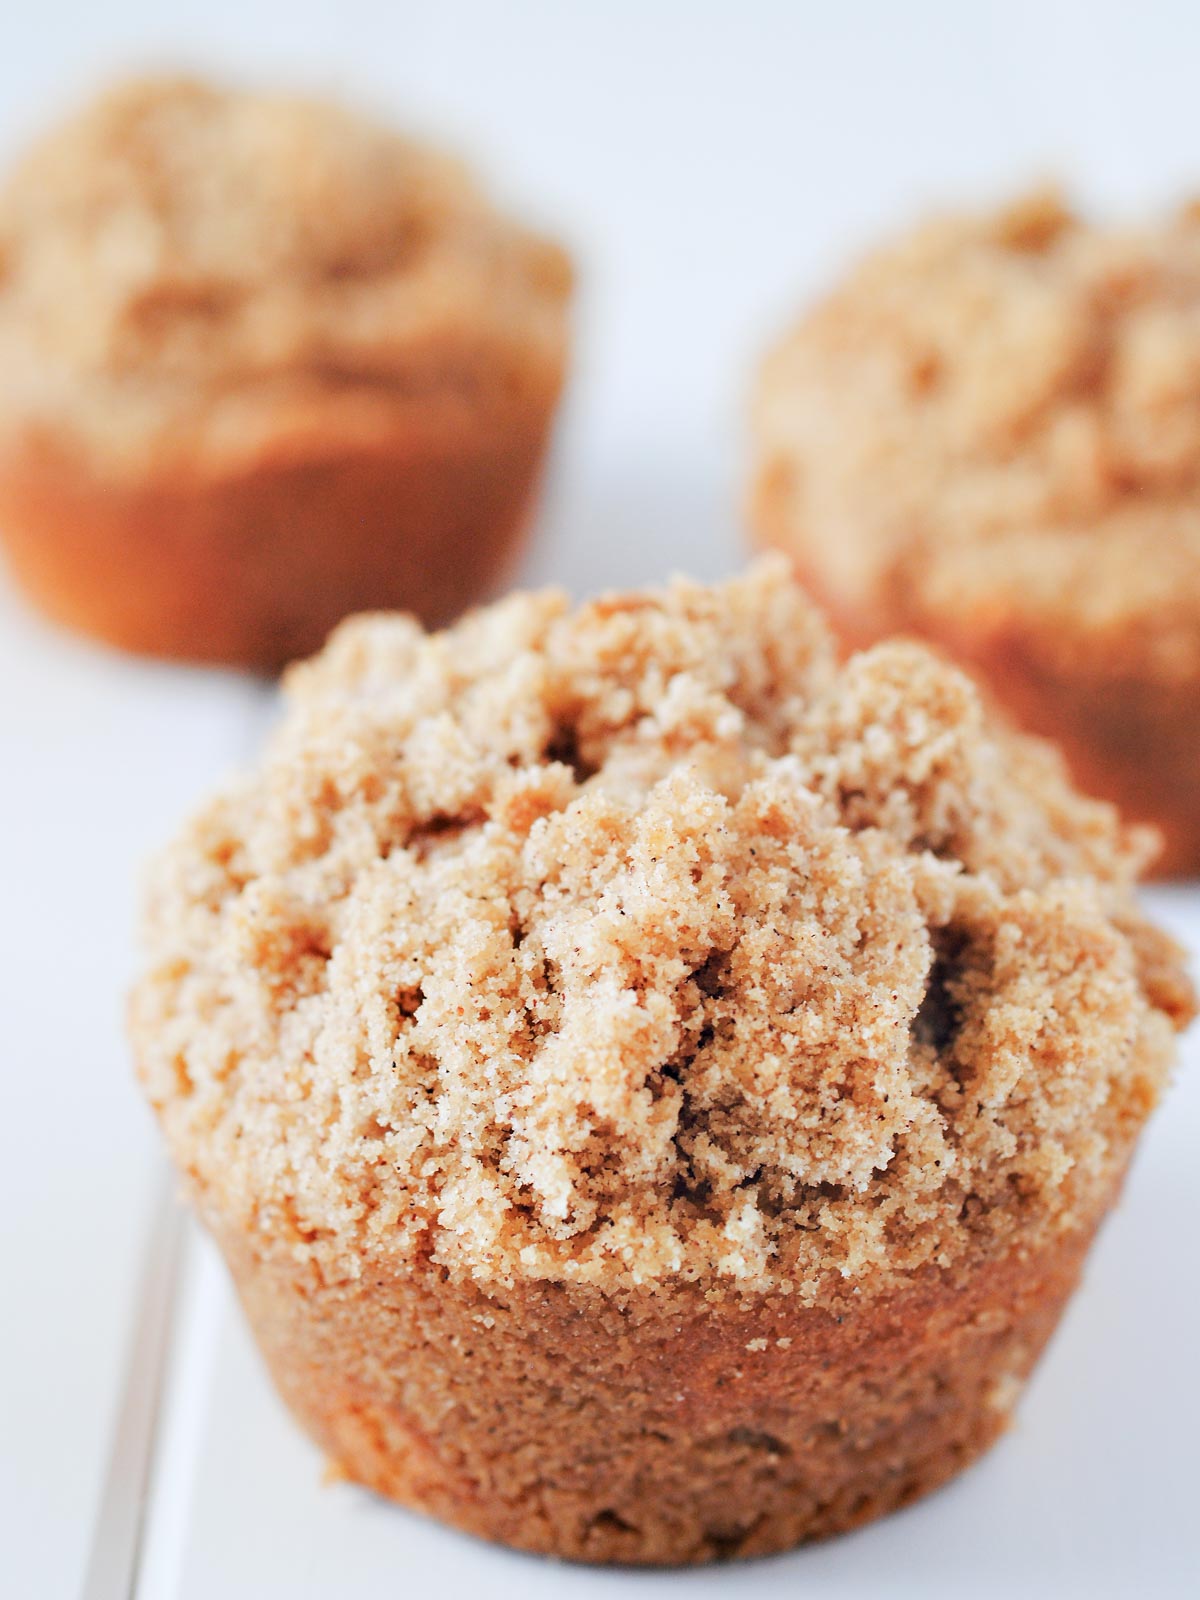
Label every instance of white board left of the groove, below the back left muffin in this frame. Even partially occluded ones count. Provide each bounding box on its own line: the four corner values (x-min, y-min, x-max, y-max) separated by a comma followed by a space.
0, 590, 260, 1600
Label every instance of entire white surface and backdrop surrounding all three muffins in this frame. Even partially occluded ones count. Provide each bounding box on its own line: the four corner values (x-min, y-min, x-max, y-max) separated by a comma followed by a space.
0, 0, 1200, 1600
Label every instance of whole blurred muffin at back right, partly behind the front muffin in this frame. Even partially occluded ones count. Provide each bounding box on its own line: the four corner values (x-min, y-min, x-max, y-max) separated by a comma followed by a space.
752, 194, 1200, 874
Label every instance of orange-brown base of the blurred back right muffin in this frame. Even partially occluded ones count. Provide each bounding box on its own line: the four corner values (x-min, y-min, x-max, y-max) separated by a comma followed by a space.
750, 474, 1200, 878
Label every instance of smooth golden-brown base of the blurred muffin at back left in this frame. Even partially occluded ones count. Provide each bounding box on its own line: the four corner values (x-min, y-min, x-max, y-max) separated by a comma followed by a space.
0, 406, 550, 670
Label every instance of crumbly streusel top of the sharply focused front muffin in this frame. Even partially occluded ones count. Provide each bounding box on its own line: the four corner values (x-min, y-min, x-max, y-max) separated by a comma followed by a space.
131, 562, 1190, 1301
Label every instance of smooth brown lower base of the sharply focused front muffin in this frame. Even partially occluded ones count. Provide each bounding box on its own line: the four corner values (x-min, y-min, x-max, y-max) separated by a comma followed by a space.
209, 1203, 1120, 1565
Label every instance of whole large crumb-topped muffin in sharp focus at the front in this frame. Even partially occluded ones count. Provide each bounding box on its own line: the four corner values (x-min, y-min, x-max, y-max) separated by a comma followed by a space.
131, 563, 1192, 1563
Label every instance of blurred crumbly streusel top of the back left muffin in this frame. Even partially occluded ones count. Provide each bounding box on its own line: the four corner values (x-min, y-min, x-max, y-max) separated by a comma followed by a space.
0, 78, 570, 467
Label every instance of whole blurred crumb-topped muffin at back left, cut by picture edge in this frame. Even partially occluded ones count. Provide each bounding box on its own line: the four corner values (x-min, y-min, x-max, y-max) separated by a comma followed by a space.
0, 78, 570, 669
